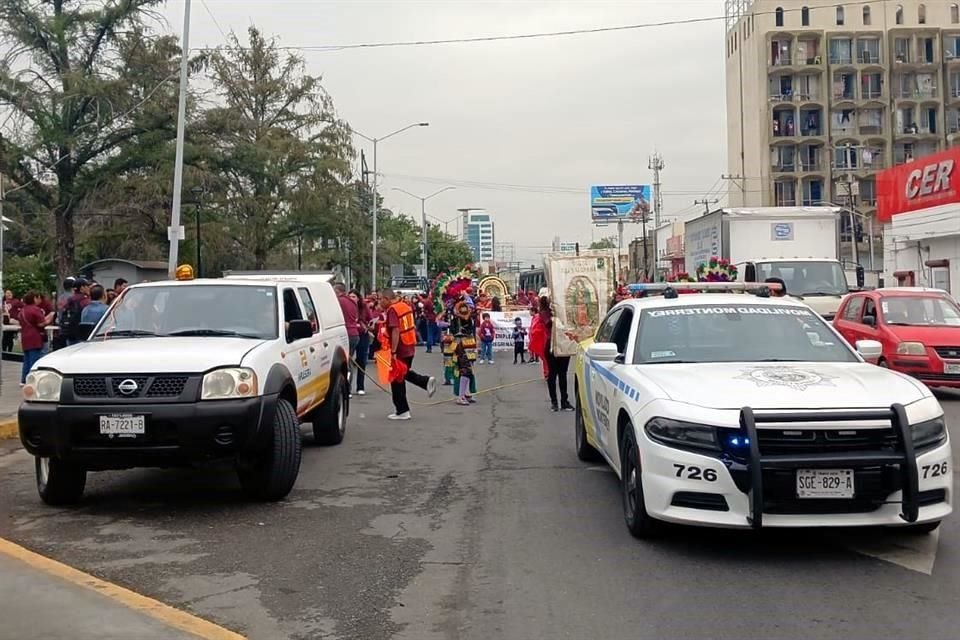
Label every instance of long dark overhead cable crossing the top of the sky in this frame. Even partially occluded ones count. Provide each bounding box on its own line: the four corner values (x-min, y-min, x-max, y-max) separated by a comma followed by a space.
193, 3, 852, 53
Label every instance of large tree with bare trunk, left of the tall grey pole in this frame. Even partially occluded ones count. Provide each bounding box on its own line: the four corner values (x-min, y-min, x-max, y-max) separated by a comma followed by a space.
0, 0, 180, 275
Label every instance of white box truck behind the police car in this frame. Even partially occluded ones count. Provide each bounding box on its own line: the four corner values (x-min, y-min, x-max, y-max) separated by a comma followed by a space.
684, 207, 862, 320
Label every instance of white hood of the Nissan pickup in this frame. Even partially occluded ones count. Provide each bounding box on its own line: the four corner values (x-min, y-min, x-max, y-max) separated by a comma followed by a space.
39, 336, 263, 374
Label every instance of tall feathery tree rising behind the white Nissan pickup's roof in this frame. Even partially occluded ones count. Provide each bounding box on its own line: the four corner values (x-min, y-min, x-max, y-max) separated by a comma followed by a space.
200, 27, 353, 269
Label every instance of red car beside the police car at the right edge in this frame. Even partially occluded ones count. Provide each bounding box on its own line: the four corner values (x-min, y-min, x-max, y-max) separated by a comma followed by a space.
833, 287, 960, 388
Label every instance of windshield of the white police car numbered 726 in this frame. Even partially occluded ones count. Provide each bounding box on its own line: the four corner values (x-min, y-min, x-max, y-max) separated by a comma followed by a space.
633, 302, 857, 364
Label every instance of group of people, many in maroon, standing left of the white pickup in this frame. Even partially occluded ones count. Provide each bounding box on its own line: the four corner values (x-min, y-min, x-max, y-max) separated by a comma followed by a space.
2, 277, 127, 385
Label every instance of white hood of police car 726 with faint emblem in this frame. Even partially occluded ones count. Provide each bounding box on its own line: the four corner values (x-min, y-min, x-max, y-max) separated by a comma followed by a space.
636, 362, 926, 409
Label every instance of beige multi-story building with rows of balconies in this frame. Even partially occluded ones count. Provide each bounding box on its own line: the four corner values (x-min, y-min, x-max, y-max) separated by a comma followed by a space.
726, 0, 960, 260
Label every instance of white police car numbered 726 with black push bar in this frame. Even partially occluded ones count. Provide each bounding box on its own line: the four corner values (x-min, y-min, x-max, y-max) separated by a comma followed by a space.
575, 283, 953, 537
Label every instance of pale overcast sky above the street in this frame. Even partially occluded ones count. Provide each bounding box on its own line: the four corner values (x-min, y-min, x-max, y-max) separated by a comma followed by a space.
164, 0, 727, 263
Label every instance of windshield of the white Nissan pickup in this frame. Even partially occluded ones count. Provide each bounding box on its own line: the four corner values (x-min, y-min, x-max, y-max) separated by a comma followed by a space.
92, 284, 279, 340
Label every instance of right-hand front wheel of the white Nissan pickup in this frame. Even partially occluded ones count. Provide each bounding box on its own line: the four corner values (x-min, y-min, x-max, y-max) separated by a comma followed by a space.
237, 398, 303, 502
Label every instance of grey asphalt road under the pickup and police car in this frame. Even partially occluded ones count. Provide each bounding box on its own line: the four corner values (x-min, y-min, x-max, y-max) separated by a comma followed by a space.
0, 355, 960, 640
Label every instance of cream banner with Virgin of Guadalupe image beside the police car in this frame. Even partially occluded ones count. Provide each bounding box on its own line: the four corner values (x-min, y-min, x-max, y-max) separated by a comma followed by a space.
543, 250, 616, 356
